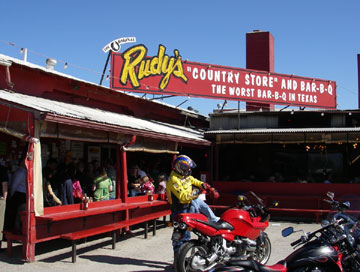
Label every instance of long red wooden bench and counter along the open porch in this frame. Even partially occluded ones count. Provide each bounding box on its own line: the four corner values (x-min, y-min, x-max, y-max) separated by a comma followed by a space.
5, 197, 170, 261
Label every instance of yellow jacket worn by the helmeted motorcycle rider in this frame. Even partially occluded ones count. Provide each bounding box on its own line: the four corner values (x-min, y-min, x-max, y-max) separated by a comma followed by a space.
166, 171, 203, 206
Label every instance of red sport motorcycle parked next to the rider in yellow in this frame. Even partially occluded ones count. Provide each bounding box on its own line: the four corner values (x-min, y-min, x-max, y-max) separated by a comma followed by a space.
172, 192, 278, 272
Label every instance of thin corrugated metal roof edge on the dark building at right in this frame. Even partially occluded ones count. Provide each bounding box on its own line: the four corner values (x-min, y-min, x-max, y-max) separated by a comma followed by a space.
205, 127, 360, 135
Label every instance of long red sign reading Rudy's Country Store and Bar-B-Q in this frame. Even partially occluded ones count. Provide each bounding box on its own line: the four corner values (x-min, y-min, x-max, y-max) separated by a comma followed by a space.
110, 45, 336, 109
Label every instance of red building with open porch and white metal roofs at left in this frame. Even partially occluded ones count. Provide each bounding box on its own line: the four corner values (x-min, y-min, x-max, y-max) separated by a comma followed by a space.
0, 52, 211, 261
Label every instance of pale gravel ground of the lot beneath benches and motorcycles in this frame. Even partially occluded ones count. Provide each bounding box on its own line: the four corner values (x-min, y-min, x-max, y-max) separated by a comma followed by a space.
0, 221, 320, 272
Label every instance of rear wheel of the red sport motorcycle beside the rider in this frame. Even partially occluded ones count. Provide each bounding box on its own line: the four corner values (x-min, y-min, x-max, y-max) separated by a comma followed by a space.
175, 240, 208, 272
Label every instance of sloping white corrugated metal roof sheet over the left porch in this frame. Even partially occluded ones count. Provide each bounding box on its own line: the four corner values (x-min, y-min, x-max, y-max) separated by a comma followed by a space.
0, 90, 210, 144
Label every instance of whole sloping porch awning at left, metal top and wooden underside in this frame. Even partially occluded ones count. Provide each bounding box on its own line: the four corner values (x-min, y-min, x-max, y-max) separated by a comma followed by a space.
0, 90, 211, 153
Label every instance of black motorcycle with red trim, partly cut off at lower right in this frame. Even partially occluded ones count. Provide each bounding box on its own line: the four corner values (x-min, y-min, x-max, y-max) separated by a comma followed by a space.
213, 192, 360, 272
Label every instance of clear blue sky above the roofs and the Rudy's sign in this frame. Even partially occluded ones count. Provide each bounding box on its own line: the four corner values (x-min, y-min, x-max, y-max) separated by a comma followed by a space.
0, 0, 360, 115
